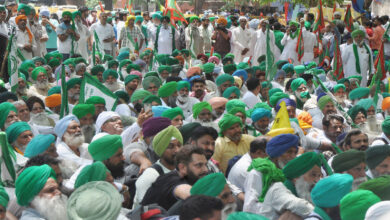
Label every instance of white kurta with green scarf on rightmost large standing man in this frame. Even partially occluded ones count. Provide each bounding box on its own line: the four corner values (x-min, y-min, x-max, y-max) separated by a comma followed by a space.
342, 44, 375, 87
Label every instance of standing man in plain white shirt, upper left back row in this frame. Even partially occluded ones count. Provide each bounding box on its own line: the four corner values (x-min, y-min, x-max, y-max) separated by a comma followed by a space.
90, 12, 115, 56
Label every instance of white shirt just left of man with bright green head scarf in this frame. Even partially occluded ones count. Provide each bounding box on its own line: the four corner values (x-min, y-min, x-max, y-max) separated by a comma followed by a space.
228, 153, 252, 192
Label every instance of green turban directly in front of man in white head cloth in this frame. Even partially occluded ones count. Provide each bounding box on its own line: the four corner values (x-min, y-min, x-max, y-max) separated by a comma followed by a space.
88, 134, 123, 161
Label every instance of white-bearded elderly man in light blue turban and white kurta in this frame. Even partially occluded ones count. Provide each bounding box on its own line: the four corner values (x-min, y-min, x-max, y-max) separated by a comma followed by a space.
54, 115, 92, 169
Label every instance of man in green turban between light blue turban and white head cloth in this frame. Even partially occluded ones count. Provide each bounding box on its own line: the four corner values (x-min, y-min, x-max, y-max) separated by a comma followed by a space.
72, 104, 96, 143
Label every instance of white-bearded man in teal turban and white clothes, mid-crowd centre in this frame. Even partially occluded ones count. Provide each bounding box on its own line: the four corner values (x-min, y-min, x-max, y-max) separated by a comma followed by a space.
176, 81, 199, 118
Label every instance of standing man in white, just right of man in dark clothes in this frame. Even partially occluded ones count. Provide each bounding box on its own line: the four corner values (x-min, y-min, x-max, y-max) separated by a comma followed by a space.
232, 16, 252, 63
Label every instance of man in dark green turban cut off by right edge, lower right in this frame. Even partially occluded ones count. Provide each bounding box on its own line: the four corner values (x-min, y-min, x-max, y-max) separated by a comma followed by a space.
366, 145, 390, 178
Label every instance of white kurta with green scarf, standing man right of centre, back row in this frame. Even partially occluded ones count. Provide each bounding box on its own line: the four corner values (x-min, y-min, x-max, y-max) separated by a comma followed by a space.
252, 29, 276, 65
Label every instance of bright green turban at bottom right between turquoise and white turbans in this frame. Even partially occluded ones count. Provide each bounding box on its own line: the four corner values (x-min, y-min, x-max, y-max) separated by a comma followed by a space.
340, 189, 381, 220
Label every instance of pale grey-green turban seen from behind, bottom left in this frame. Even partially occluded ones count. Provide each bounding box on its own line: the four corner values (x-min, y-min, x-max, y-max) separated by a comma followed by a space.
66, 181, 123, 220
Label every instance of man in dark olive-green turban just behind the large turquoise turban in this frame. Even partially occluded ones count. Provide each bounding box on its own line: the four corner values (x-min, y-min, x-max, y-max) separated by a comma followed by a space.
331, 149, 367, 190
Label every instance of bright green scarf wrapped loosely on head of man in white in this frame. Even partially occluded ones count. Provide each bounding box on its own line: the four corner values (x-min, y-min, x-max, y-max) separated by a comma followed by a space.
248, 157, 285, 202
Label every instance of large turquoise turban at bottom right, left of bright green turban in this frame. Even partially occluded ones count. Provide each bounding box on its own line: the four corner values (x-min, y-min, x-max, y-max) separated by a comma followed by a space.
311, 173, 353, 208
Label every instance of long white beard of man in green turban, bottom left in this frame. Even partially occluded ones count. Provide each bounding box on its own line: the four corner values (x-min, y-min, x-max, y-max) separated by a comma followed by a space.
31, 194, 68, 220
